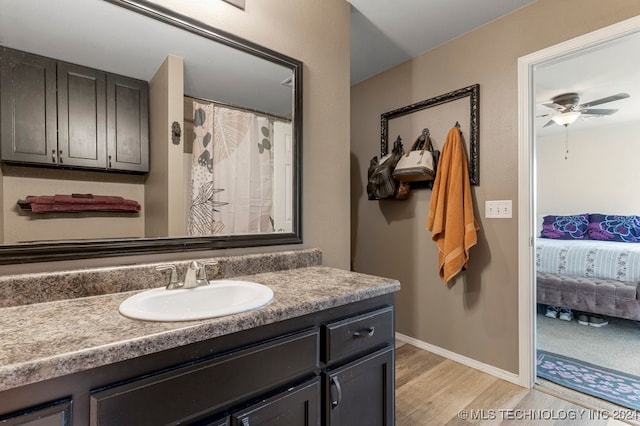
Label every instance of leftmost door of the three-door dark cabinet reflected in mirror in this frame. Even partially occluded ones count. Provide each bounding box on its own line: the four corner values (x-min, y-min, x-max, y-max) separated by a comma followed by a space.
0, 49, 57, 164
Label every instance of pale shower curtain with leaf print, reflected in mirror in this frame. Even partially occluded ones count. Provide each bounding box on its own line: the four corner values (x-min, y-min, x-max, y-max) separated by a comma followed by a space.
189, 101, 273, 236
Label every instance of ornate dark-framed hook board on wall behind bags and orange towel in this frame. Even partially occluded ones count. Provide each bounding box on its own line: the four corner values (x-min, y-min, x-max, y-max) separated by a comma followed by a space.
380, 84, 480, 188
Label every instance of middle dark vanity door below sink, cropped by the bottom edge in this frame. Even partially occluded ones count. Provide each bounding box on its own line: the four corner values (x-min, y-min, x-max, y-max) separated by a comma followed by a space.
231, 378, 320, 426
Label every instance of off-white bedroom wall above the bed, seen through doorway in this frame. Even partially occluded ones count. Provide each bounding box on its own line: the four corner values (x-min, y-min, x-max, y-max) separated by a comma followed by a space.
536, 117, 640, 228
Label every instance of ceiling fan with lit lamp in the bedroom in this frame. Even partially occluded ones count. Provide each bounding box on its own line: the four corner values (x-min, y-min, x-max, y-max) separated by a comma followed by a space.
538, 93, 629, 127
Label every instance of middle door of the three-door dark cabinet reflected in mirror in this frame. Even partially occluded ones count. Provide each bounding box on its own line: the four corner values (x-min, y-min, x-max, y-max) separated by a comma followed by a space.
58, 62, 107, 168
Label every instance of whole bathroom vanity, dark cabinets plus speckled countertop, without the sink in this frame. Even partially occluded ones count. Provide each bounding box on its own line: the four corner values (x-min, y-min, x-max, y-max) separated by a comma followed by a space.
0, 251, 399, 425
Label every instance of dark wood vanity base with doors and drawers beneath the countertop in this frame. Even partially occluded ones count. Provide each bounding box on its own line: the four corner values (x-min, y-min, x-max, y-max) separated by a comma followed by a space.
0, 295, 395, 426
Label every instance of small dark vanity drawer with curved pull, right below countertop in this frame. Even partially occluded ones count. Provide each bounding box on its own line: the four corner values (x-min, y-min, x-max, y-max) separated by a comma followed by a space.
324, 306, 394, 364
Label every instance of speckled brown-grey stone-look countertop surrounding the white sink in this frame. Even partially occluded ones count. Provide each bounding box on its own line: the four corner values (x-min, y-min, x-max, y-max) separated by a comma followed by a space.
0, 266, 400, 391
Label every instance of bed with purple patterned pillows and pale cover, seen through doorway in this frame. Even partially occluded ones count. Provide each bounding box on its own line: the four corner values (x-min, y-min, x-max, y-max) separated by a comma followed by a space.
535, 214, 640, 320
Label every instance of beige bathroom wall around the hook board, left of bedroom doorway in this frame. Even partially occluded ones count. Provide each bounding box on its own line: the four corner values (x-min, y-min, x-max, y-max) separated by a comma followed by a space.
351, 0, 640, 373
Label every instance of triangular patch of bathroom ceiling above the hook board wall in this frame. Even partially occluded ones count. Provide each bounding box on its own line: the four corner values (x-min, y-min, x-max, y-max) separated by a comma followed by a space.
347, 0, 535, 84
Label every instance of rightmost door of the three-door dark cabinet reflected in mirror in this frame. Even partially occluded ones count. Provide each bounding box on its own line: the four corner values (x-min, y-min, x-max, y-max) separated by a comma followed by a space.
107, 74, 149, 172
